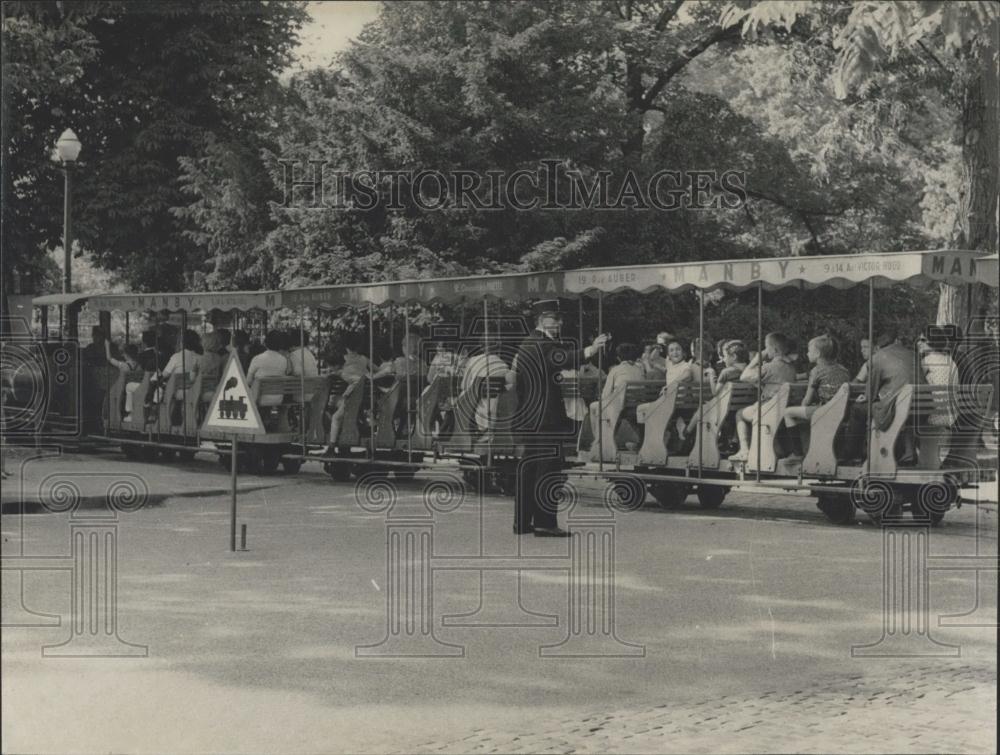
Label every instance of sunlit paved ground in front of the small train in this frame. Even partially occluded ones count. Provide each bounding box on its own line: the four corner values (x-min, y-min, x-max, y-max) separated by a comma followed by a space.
2, 446, 997, 752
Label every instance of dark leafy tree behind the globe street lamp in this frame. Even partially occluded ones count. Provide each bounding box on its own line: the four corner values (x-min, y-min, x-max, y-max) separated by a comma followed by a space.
3, 0, 306, 290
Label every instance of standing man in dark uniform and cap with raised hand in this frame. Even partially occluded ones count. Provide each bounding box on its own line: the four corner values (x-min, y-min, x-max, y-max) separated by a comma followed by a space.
512, 299, 607, 537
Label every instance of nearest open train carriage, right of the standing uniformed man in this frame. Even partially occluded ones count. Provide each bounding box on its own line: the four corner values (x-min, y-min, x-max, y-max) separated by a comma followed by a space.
566, 250, 998, 523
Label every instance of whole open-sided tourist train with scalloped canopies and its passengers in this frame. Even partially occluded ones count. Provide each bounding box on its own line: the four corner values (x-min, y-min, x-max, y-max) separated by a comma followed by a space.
4, 250, 997, 523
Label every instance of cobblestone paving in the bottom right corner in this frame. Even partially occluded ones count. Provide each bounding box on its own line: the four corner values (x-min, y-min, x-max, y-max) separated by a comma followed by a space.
413, 664, 997, 753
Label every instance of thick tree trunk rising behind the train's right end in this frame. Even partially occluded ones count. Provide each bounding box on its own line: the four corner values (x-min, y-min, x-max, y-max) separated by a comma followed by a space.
937, 41, 1000, 324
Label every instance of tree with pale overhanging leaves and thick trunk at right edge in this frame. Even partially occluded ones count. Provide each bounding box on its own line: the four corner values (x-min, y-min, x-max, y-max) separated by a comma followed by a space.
720, 2, 1000, 323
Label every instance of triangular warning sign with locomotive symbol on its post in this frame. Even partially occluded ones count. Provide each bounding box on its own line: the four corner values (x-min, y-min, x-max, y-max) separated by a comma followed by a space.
201, 353, 264, 552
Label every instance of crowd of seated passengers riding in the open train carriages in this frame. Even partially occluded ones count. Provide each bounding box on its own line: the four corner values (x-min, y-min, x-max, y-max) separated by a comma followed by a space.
82, 314, 997, 461
